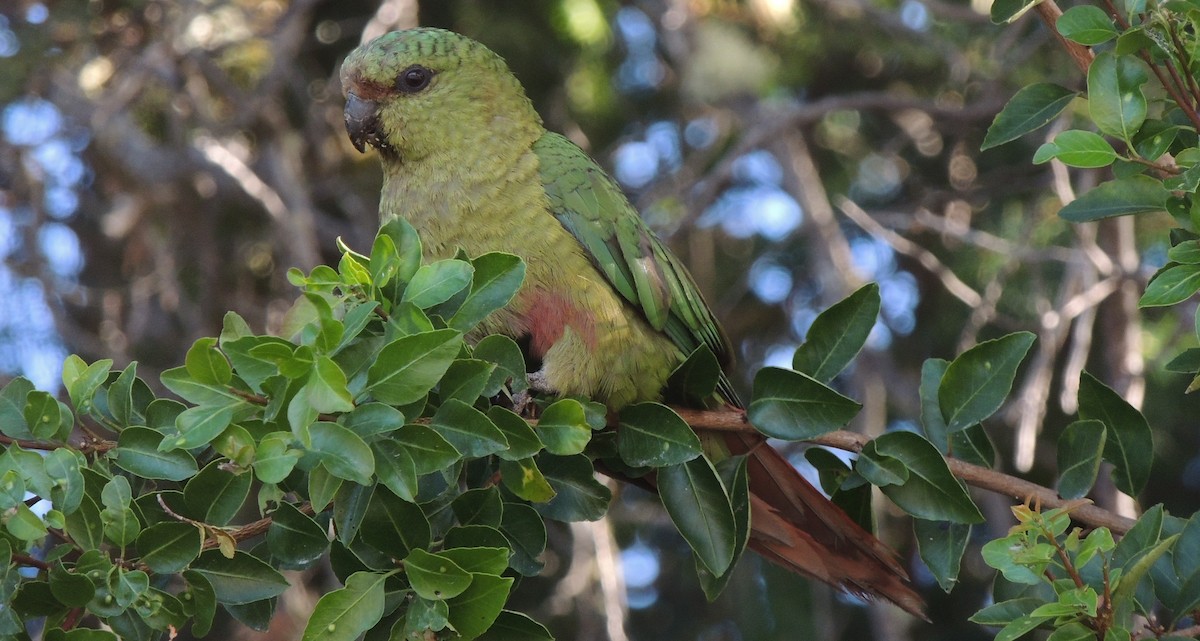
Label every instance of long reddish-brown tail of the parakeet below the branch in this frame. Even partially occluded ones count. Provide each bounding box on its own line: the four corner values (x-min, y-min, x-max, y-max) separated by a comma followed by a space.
726, 433, 925, 618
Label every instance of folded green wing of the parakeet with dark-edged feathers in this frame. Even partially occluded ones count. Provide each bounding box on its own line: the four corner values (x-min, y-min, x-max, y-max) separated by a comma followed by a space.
533, 133, 738, 403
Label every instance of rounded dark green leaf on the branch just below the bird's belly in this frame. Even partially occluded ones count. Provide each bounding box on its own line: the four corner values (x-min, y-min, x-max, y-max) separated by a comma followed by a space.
617, 403, 702, 467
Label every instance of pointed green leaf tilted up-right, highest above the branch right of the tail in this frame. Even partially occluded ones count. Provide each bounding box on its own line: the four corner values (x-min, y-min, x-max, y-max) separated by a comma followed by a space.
937, 331, 1037, 432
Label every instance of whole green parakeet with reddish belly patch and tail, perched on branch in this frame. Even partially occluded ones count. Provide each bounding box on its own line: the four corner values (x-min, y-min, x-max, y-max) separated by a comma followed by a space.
341, 29, 922, 616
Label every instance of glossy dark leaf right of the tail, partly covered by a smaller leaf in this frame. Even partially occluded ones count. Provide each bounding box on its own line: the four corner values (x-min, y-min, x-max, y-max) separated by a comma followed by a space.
859, 431, 983, 523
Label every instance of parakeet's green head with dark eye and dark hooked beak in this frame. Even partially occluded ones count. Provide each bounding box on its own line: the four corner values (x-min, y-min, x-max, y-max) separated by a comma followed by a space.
341, 29, 541, 162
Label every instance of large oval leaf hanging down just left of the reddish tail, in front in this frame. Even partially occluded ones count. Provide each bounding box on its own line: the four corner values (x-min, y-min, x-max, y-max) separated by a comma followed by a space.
658, 456, 737, 576
